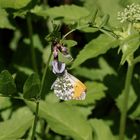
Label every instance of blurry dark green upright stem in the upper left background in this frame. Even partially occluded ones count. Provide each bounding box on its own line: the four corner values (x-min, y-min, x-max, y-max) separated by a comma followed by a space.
27, 15, 38, 73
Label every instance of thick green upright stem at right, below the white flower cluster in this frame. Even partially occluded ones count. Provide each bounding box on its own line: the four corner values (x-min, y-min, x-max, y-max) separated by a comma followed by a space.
119, 63, 134, 140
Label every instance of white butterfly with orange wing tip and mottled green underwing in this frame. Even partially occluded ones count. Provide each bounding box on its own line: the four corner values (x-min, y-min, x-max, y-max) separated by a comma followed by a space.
51, 70, 87, 100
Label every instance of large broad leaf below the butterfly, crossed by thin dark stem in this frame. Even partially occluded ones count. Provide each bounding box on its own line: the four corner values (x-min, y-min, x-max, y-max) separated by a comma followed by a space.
26, 101, 92, 140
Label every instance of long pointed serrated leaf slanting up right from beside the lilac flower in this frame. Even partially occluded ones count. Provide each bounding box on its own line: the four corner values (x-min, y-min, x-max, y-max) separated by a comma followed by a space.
71, 35, 118, 68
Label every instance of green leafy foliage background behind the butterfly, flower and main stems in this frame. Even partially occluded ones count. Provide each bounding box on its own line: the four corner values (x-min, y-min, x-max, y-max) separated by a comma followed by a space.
0, 0, 140, 140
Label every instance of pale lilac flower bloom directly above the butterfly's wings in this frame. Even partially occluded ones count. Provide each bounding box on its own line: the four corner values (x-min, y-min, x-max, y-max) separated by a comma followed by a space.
52, 60, 66, 74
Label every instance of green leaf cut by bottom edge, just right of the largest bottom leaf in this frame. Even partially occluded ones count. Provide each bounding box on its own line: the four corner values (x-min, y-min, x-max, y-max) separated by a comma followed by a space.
90, 119, 117, 140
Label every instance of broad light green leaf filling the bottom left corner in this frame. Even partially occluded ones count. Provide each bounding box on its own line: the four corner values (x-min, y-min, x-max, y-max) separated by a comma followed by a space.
0, 107, 33, 140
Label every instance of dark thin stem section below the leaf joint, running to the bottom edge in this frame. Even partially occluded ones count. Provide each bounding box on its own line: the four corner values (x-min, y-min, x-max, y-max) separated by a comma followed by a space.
31, 101, 39, 140
